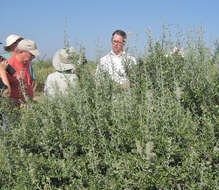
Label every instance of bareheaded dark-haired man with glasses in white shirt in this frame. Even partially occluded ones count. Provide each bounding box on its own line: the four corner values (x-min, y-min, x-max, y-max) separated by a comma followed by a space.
96, 30, 136, 88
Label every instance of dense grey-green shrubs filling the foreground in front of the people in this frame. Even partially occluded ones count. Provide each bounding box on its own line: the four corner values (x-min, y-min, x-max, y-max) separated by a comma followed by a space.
0, 29, 219, 190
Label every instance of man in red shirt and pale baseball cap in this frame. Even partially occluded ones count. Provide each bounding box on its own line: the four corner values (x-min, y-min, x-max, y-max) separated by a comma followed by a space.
7, 39, 40, 106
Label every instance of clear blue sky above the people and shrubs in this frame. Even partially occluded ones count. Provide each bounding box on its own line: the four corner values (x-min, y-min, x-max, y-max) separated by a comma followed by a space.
0, 0, 219, 60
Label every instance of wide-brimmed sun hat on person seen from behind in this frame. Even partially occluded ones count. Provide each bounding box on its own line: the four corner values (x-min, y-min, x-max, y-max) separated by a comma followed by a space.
52, 47, 76, 71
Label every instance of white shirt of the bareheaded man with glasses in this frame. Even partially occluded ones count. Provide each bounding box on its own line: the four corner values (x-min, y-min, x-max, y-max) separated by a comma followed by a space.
96, 51, 137, 85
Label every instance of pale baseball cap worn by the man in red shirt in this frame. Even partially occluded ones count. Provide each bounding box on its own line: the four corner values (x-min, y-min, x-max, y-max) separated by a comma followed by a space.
17, 39, 40, 57
